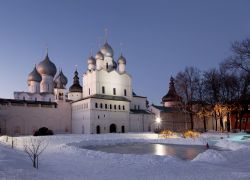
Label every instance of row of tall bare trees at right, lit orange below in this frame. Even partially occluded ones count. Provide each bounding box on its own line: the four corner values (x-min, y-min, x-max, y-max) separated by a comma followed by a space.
175, 38, 250, 131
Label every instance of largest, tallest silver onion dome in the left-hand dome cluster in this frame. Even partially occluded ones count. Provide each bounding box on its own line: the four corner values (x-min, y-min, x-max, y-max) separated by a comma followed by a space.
37, 54, 56, 77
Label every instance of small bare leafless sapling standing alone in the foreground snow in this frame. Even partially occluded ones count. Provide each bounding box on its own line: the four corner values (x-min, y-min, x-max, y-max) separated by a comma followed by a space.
23, 137, 48, 169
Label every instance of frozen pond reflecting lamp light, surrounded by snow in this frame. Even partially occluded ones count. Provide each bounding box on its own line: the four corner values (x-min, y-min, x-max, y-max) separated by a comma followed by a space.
82, 143, 221, 160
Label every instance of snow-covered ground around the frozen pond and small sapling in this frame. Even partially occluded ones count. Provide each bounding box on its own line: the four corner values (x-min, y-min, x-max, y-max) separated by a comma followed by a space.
0, 133, 250, 180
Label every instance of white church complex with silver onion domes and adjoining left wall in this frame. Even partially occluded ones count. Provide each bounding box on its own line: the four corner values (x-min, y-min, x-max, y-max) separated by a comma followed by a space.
0, 42, 156, 135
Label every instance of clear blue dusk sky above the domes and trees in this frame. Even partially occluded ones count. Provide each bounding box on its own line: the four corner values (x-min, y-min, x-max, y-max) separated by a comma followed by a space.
0, 0, 250, 104
